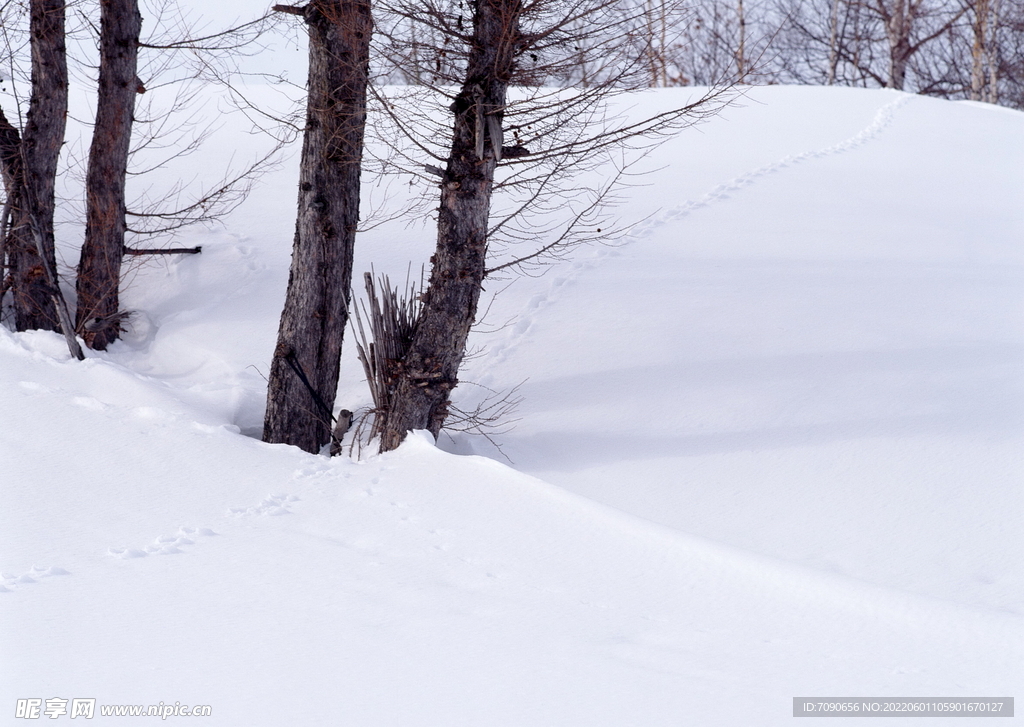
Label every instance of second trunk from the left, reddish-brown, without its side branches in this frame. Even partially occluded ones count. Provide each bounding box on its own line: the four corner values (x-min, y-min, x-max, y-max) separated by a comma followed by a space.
76, 0, 142, 350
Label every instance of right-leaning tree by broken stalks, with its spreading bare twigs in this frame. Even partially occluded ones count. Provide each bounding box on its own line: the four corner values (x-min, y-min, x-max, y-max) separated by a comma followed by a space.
374, 0, 718, 450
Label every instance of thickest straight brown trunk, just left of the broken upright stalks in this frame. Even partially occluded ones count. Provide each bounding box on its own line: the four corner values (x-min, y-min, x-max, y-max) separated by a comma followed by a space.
263, 0, 373, 453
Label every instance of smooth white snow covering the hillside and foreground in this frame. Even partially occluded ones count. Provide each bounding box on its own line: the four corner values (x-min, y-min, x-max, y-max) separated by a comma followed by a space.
0, 87, 1024, 727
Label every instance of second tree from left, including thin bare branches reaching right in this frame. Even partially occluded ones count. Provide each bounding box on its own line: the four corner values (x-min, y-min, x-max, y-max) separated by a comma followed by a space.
71, 0, 276, 350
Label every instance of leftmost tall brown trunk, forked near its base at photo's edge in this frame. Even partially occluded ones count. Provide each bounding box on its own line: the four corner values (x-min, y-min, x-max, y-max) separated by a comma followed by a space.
7, 0, 68, 331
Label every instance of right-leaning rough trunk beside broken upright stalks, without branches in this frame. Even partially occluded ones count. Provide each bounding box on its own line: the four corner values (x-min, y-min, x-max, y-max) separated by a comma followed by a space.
381, 0, 522, 451
